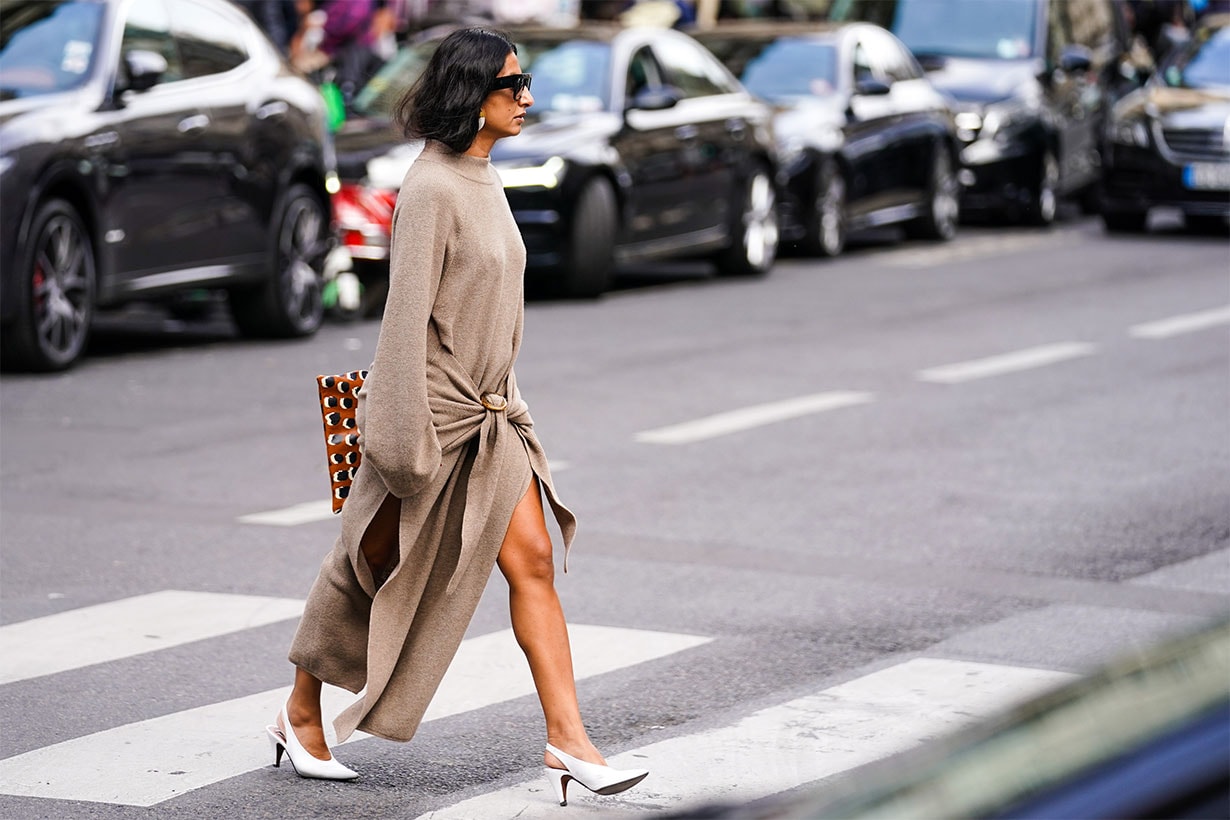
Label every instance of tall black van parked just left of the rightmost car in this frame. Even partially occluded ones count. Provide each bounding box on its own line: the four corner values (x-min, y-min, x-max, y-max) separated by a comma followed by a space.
831, 0, 1127, 225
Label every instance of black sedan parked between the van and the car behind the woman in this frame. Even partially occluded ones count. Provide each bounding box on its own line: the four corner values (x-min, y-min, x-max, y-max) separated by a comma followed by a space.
695, 21, 959, 256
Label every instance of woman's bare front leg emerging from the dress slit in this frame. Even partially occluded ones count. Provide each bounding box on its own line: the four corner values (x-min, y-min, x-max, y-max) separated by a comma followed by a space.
497, 478, 606, 768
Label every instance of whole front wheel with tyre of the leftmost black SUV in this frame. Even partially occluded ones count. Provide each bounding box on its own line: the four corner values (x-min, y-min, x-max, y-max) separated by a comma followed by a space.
0, 199, 96, 371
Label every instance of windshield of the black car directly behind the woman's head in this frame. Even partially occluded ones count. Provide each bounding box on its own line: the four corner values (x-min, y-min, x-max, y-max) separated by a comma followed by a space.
354, 38, 610, 117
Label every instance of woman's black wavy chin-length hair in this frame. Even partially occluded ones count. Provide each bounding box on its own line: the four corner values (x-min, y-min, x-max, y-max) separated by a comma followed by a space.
395, 28, 517, 154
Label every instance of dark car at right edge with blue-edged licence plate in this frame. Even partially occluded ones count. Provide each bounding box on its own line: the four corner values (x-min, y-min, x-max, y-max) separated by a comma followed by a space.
1102, 15, 1230, 231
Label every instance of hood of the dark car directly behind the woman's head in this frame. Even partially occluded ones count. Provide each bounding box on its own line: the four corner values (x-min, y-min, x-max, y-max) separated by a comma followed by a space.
333, 113, 620, 189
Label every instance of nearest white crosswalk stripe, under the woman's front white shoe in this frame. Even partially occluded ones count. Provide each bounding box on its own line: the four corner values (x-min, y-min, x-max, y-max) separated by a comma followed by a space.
418, 658, 1075, 820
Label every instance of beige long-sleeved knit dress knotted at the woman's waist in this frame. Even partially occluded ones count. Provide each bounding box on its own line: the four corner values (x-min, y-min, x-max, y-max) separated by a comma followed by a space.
290, 140, 576, 740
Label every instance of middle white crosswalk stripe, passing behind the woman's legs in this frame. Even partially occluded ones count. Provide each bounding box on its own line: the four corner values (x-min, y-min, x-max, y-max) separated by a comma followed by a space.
0, 623, 711, 806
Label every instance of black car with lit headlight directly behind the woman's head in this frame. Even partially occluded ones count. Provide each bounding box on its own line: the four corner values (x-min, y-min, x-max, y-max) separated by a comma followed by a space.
336, 23, 777, 296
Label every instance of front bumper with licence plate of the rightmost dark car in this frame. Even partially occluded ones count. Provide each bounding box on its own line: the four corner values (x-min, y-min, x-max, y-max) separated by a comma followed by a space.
1102, 145, 1230, 216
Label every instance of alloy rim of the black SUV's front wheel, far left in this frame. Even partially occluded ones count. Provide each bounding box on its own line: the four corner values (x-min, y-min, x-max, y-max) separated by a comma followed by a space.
31, 214, 91, 358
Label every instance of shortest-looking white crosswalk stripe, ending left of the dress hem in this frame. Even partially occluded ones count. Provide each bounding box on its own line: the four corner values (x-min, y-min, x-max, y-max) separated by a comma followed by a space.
0, 590, 304, 684
